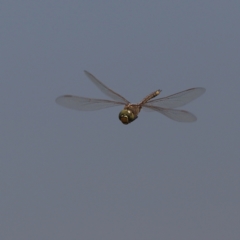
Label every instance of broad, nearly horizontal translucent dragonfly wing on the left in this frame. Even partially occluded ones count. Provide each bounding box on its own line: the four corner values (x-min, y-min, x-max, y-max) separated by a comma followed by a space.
56, 95, 124, 111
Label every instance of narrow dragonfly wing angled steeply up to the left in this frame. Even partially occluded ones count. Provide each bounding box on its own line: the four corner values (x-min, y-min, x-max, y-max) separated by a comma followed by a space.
84, 70, 129, 104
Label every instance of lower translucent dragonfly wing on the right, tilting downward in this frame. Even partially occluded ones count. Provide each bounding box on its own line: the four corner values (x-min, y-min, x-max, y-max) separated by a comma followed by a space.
143, 105, 197, 122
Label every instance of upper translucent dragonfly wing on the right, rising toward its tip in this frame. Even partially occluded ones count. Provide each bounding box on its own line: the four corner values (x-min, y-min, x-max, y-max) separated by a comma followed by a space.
145, 88, 206, 108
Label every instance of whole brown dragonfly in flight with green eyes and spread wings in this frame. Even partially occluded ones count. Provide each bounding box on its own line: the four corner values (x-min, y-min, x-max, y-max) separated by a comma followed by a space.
56, 71, 206, 125
